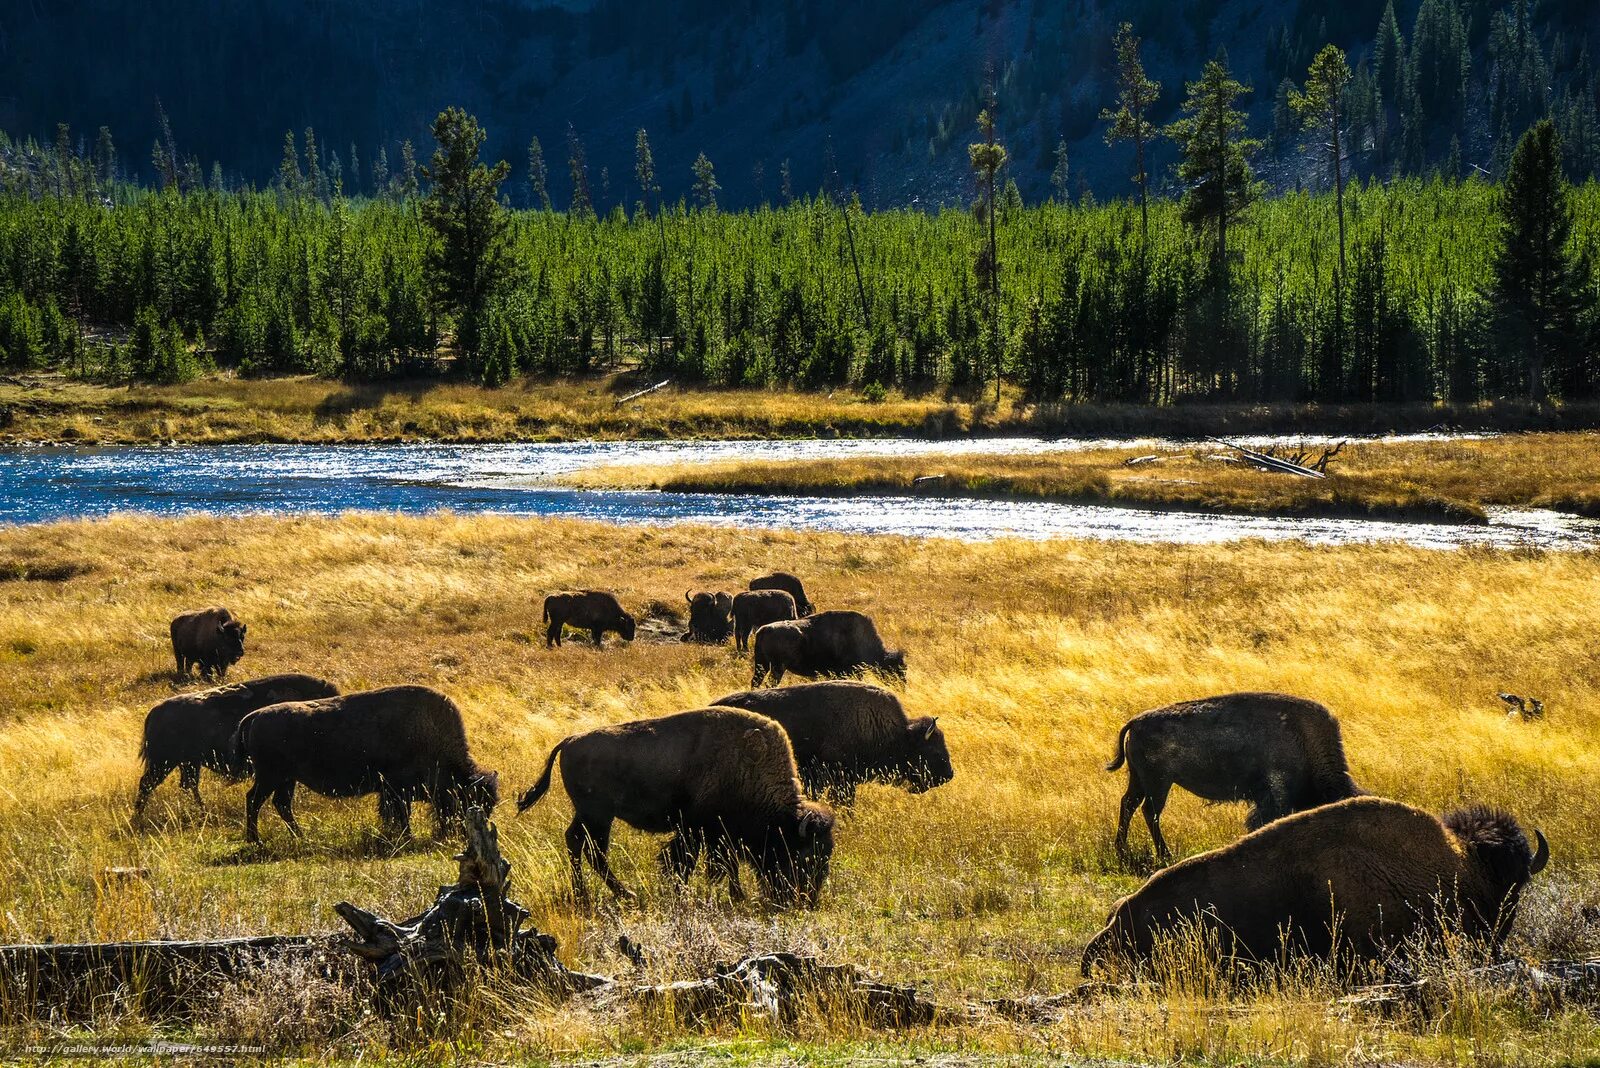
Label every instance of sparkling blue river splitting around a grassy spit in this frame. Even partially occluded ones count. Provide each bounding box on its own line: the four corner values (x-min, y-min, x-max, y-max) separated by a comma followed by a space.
0, 438, 1600, 548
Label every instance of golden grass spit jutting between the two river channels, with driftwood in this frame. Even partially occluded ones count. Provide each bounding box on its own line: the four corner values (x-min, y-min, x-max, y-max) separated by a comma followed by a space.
563, 432, 1600, 523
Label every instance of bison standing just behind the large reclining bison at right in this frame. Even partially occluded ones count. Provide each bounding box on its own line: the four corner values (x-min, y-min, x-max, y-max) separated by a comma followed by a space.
1106, 694, 1362, 862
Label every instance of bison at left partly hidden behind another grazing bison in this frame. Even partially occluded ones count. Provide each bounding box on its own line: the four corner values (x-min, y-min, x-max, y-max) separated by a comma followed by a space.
133, 675, 339, 815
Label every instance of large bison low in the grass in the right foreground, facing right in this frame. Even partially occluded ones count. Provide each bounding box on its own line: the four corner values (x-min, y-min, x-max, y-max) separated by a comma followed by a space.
1083, 798, 1550, 975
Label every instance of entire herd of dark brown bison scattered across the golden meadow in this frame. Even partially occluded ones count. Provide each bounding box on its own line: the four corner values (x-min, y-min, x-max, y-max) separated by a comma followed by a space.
134, 572, 1549, 974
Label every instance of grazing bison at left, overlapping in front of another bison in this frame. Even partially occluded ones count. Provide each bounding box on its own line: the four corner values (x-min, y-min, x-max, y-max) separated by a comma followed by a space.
232, 686, 499, 841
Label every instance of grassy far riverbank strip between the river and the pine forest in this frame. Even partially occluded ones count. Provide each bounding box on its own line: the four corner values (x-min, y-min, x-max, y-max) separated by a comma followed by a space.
0, 373, 1600, 444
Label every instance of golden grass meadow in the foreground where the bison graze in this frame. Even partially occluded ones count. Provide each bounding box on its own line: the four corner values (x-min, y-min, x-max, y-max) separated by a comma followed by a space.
0, 515, 1600, 1065
